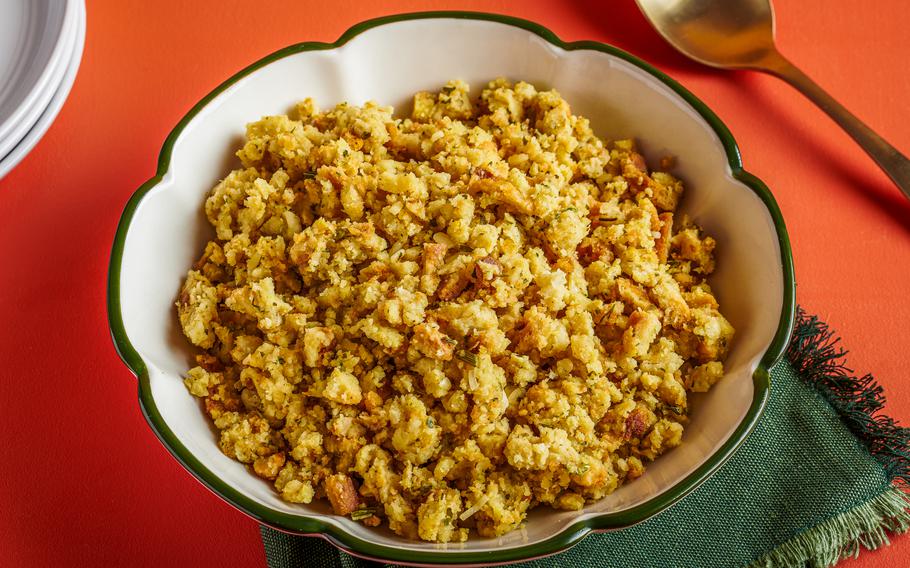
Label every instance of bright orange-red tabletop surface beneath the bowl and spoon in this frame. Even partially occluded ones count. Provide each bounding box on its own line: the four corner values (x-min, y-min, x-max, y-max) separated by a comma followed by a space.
0, 0, 910, 567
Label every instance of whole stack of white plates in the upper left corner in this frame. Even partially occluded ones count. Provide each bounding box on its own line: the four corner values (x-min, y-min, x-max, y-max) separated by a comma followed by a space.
0, 0, 85, 178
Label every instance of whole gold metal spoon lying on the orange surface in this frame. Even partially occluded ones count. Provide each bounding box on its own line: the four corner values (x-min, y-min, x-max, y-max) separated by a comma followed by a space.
635, 0, 910, 199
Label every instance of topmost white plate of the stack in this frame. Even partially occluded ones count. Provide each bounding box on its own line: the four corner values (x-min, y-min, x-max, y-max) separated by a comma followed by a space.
0, 0, 81, 148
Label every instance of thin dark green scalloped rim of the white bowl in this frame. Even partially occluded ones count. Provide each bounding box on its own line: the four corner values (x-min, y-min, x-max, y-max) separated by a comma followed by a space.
107, 11, 795, 564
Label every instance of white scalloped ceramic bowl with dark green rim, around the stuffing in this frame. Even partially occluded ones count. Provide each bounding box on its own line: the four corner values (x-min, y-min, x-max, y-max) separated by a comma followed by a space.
108, 12, 794, 564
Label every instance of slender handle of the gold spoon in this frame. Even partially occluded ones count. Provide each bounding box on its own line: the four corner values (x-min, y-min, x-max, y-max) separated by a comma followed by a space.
767, 56, 910, 199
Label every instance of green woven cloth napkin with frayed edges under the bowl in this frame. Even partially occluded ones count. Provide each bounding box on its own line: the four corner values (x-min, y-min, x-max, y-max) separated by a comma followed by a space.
262, 311, 910, 568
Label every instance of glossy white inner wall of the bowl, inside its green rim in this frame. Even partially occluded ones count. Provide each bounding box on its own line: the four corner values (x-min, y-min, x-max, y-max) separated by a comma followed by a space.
120, 18, 783, 551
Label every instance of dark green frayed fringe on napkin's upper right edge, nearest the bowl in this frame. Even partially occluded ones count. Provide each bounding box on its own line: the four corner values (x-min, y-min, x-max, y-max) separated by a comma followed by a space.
787, 308, 910, 491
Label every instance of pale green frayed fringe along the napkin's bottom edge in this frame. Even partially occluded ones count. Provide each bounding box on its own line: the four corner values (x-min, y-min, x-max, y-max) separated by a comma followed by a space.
750, 487, 910, 568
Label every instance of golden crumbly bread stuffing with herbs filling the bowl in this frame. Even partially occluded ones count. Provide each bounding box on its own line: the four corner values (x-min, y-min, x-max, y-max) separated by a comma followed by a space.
177, 79, 733, 542
